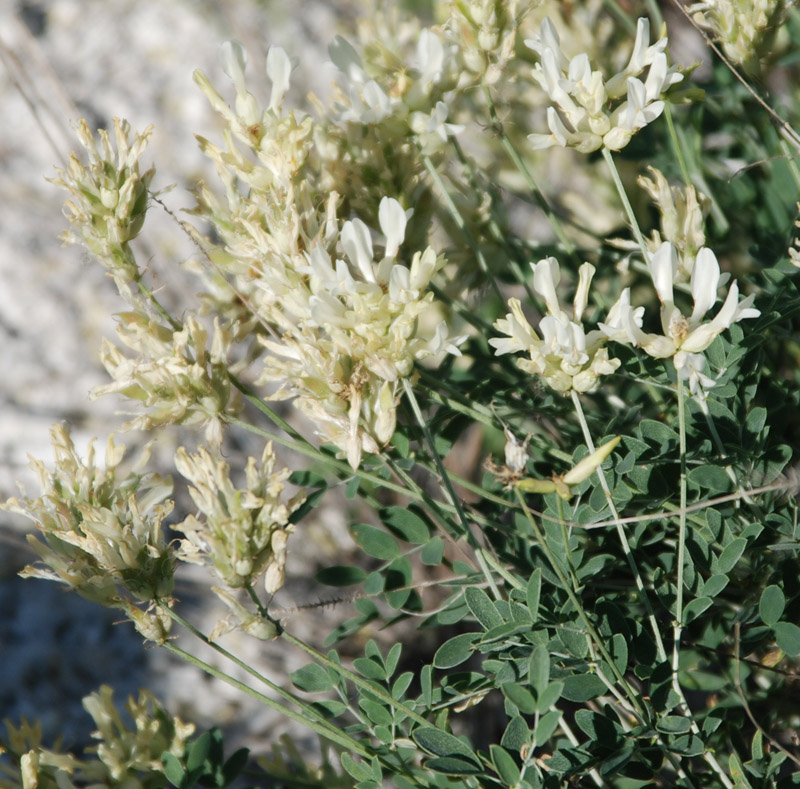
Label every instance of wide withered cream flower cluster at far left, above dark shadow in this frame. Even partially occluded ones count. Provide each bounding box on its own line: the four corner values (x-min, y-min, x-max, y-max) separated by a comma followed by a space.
2, 425, 173, 640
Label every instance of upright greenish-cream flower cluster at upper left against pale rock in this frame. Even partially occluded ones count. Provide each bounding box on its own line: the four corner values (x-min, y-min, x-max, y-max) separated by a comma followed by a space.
53, 118, 155, 290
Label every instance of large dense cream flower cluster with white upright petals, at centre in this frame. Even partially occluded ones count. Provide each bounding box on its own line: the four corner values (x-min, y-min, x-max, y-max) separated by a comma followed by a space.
261, 198, 462, 468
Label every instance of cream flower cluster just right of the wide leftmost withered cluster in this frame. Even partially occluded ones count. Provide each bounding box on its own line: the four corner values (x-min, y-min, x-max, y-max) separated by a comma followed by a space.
174, 444, 305, 594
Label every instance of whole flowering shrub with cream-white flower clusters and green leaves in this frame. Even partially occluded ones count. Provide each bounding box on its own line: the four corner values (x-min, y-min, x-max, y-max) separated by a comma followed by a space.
0, 0, 800, 789
